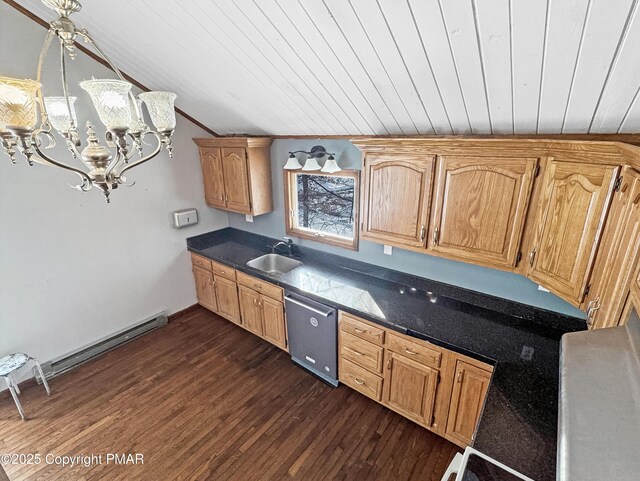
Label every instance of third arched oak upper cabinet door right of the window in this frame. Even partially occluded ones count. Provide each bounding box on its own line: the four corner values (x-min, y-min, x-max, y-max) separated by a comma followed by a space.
528, 161, 618, 305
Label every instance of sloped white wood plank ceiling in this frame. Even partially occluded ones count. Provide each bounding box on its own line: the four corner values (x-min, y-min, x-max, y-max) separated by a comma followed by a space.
12, 0, 640, 135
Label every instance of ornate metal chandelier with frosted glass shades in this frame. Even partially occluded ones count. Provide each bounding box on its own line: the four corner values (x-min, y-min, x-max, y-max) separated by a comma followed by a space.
0, 0, 176, 202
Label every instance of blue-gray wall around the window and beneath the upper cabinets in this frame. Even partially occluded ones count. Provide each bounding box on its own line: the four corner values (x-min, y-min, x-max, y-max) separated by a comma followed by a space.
229, 139, 584, 318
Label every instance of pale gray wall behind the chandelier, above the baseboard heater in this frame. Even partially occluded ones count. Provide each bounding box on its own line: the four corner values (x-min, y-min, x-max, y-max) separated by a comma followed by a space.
0, 2, 228, 378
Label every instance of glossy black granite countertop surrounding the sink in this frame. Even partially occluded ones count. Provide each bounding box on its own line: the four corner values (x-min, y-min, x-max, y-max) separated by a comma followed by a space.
187, 228, 586, 481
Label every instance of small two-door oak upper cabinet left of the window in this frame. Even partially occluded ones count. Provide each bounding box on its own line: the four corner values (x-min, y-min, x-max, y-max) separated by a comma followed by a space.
194, 137, 273, 215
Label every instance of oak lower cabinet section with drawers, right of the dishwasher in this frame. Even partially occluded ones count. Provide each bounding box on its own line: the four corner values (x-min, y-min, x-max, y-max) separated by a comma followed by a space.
338, 311, 493, 447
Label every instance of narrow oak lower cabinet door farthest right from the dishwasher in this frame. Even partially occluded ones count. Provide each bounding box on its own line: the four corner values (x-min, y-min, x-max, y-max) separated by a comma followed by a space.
446, 360, 491, 445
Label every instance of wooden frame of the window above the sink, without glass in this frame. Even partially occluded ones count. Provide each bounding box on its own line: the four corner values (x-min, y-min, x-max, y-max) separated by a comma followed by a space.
284, 169, 360, 251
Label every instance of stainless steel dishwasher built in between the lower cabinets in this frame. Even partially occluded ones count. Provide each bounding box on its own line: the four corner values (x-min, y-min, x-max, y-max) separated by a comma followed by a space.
284, 291, 338, 387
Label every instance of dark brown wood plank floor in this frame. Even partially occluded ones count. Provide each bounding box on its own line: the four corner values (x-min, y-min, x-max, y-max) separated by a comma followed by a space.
0, 309, 457, 481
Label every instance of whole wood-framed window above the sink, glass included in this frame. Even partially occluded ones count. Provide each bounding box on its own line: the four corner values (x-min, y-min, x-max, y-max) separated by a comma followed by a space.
284, 170, 360, 250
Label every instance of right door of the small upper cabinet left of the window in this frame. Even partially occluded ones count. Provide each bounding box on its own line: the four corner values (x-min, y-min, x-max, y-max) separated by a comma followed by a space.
221, 147, 251, 214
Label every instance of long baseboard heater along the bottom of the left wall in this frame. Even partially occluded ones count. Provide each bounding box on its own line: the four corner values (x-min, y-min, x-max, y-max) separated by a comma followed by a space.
33, 311, 168, 383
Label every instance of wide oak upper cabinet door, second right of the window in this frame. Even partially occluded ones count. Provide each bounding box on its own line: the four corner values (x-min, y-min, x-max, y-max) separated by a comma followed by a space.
429, 156, 538, 268
